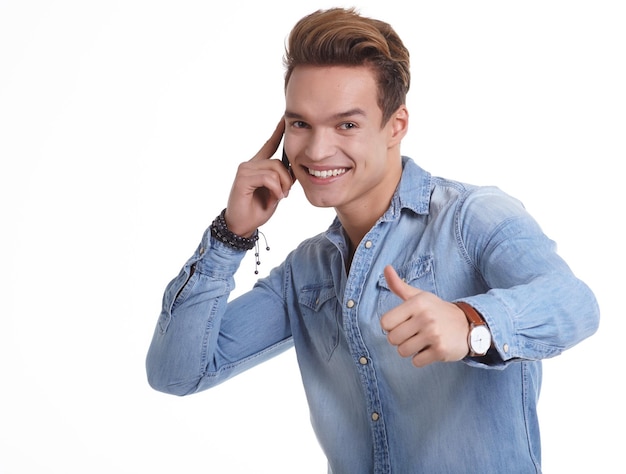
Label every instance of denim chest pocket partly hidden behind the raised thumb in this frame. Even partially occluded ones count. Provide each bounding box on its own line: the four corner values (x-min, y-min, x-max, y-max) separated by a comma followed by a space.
377, 255, 437, 318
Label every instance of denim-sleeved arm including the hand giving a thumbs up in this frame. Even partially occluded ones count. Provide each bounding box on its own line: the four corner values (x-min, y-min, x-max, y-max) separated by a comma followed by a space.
381, 188, 599, 367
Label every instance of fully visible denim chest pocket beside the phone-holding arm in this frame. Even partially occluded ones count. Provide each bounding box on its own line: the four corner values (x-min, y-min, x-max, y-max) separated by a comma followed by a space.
298, 281, 341, 360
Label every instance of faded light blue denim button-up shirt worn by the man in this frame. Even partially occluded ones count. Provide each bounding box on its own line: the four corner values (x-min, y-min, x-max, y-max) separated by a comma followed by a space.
147, 157, 599, 474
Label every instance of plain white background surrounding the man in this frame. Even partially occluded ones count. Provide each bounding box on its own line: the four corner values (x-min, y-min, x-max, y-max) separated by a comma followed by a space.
0, 0, 626, 474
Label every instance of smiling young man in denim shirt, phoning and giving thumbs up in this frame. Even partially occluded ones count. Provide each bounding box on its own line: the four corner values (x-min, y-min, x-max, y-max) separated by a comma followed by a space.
147, 9, 599, 474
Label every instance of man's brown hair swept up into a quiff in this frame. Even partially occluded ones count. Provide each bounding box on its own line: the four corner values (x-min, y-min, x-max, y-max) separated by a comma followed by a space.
283, 8, 411, 125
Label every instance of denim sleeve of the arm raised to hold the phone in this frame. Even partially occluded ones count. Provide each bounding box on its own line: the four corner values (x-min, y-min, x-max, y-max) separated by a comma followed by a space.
146, 231, 291, 395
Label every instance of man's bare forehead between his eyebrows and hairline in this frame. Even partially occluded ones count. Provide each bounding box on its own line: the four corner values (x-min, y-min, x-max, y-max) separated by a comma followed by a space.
285, 66, 382, 118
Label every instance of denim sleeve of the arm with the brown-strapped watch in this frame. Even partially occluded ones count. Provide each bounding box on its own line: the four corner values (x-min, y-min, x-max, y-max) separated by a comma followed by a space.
458, 189, 599, 365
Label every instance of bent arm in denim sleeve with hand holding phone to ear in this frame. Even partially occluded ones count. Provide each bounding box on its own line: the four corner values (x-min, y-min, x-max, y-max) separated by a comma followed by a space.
146, 121, 293, 395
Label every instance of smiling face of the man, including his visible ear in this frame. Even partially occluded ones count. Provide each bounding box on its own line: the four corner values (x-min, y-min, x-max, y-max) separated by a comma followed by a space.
285, 66, 402, 213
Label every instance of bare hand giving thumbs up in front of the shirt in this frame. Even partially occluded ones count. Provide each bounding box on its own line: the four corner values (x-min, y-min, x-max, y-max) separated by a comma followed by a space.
380, 265, 469, 367
